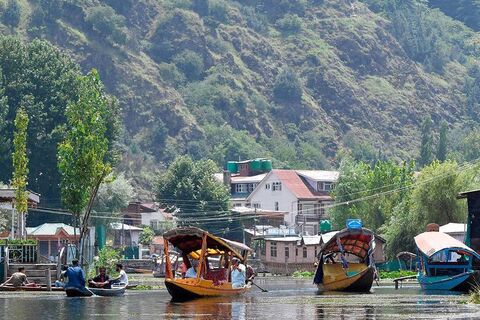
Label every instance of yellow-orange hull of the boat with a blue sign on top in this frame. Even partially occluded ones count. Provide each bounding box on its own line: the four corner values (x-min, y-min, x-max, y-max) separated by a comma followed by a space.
317, 264, 375, 292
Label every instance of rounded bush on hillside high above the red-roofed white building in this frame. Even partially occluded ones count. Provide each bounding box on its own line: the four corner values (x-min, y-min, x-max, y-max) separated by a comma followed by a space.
273, 69, 303, 103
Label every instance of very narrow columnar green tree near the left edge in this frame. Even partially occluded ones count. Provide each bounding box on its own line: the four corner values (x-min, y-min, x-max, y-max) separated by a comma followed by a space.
12, 109, 29, 238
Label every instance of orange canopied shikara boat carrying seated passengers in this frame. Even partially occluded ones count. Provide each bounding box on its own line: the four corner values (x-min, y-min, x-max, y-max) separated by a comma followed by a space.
163, 227, 251, 300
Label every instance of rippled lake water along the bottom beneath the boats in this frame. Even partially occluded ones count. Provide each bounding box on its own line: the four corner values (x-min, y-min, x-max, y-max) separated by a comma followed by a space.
0, 278, 480, 320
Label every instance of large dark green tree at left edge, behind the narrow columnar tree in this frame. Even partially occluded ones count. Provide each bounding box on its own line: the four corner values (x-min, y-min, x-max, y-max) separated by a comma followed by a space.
0, 36, 80, 207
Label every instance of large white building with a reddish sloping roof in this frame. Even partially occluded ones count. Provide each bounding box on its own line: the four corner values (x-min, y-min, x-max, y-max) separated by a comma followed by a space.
247, 169, 339, 235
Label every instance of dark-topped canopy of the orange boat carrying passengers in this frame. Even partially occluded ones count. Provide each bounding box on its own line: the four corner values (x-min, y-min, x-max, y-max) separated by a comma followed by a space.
163, 227, 252, 261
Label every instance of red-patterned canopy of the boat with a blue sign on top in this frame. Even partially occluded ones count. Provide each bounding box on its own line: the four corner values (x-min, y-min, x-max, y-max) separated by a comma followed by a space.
321, 228, 375, 259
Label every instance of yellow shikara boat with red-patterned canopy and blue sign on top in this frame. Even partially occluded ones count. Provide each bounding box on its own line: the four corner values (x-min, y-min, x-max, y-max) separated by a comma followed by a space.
314, 226, 376, 292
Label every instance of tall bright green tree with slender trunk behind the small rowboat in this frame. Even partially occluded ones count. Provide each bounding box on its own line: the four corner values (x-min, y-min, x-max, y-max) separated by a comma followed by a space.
58, 70, 118, 255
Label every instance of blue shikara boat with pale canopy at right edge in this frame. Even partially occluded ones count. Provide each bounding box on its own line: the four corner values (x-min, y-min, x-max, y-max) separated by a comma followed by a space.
415, 231, 480, 292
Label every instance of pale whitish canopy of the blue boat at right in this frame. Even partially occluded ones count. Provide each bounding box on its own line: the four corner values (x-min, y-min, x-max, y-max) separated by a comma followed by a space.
415, 231, 480, 259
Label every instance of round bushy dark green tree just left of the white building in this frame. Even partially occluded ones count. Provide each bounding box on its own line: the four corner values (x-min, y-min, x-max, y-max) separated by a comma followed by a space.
157, 156, 232, 234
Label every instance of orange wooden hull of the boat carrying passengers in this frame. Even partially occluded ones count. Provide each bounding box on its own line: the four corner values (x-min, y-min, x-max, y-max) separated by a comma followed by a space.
165, 279, 249, 300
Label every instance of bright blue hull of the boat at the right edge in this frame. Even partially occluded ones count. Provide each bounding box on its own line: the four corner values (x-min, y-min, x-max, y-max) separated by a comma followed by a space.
417, 270, 480, 292
